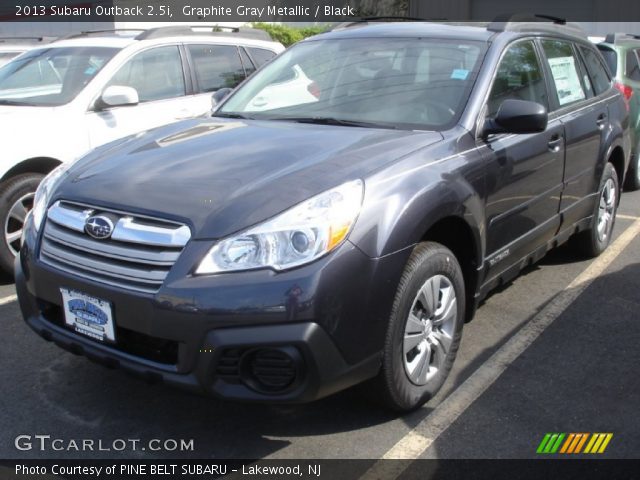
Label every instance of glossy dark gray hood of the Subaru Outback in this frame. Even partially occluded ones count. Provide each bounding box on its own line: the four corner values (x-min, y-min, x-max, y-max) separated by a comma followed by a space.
55, 118, 442, 239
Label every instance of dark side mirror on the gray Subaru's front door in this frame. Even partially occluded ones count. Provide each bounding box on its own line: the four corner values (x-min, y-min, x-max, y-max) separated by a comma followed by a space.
482, 99, 549, 137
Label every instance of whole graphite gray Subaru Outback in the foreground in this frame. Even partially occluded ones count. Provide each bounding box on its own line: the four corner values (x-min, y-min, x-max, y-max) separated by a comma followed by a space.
15, 16, 630, 411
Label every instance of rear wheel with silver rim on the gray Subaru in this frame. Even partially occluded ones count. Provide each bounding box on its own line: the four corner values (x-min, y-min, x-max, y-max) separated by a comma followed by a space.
573, 163, 620, 257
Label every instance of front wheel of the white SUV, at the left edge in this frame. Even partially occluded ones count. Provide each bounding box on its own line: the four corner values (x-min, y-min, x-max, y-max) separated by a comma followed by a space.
0, 173, 44, 275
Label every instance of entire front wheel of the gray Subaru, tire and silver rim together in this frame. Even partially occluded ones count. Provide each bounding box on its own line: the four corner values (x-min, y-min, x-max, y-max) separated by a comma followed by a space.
373, 242, 465, 412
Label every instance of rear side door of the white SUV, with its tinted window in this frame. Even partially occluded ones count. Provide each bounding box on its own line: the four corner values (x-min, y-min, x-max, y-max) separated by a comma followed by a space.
185, 44, 255, 110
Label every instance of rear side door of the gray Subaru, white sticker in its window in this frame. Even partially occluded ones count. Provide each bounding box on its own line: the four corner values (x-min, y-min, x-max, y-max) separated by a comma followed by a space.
540, 38, 609, 227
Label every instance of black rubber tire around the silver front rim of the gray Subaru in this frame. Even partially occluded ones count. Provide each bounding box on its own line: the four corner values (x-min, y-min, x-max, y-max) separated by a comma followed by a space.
371, 242, 465, 412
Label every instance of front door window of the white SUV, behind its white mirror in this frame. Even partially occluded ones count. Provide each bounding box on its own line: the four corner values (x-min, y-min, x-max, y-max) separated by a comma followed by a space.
109, 46, 185, 102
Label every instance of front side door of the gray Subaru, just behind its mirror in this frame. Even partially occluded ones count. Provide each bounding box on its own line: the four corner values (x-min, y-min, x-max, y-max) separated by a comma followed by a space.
479, 40, 564, 274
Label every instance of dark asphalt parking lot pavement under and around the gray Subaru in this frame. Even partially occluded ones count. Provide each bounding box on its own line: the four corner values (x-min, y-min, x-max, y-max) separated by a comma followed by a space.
0, 188, 640, 459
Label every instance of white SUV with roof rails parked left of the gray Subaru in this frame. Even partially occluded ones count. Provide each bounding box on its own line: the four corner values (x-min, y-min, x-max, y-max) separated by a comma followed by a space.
0, 27, 284, 272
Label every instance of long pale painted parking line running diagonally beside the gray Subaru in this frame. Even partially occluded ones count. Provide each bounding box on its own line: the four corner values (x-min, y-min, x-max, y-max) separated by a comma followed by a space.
361, 219, 640, 480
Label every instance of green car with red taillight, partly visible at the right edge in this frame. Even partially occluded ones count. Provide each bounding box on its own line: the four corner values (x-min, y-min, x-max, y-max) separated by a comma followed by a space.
598, 33, 640, 190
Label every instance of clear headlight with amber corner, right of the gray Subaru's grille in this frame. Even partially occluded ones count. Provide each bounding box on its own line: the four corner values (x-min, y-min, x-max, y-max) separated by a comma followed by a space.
196, 180, 364, 274
